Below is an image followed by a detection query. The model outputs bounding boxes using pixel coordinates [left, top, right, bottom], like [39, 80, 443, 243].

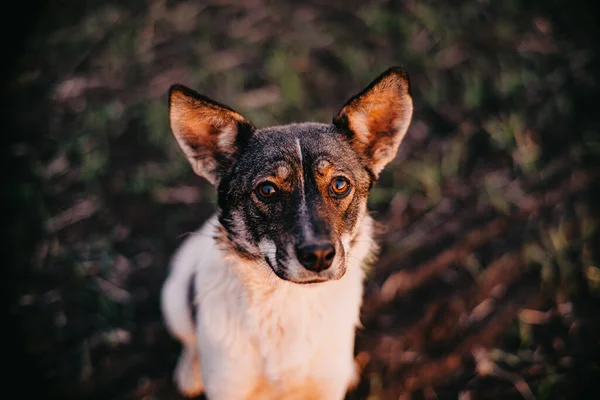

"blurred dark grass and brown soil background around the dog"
[2, 0, 600, 400]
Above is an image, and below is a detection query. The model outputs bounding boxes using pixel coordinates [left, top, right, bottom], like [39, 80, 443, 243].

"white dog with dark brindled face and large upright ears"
[161, 67, 413, 400]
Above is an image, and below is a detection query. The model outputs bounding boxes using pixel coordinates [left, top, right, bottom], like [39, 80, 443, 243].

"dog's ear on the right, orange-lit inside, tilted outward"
[333, 67, 413, 177]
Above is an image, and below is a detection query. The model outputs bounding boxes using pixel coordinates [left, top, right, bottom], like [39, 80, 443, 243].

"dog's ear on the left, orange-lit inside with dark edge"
[169, 85, 255, 184]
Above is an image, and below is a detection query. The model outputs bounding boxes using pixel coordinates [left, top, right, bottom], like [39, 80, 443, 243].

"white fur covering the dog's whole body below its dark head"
[162, 216, 373, 400]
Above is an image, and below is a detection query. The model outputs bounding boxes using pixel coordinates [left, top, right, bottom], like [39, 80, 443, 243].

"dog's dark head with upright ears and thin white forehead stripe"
[169, 67, 413, 283]
